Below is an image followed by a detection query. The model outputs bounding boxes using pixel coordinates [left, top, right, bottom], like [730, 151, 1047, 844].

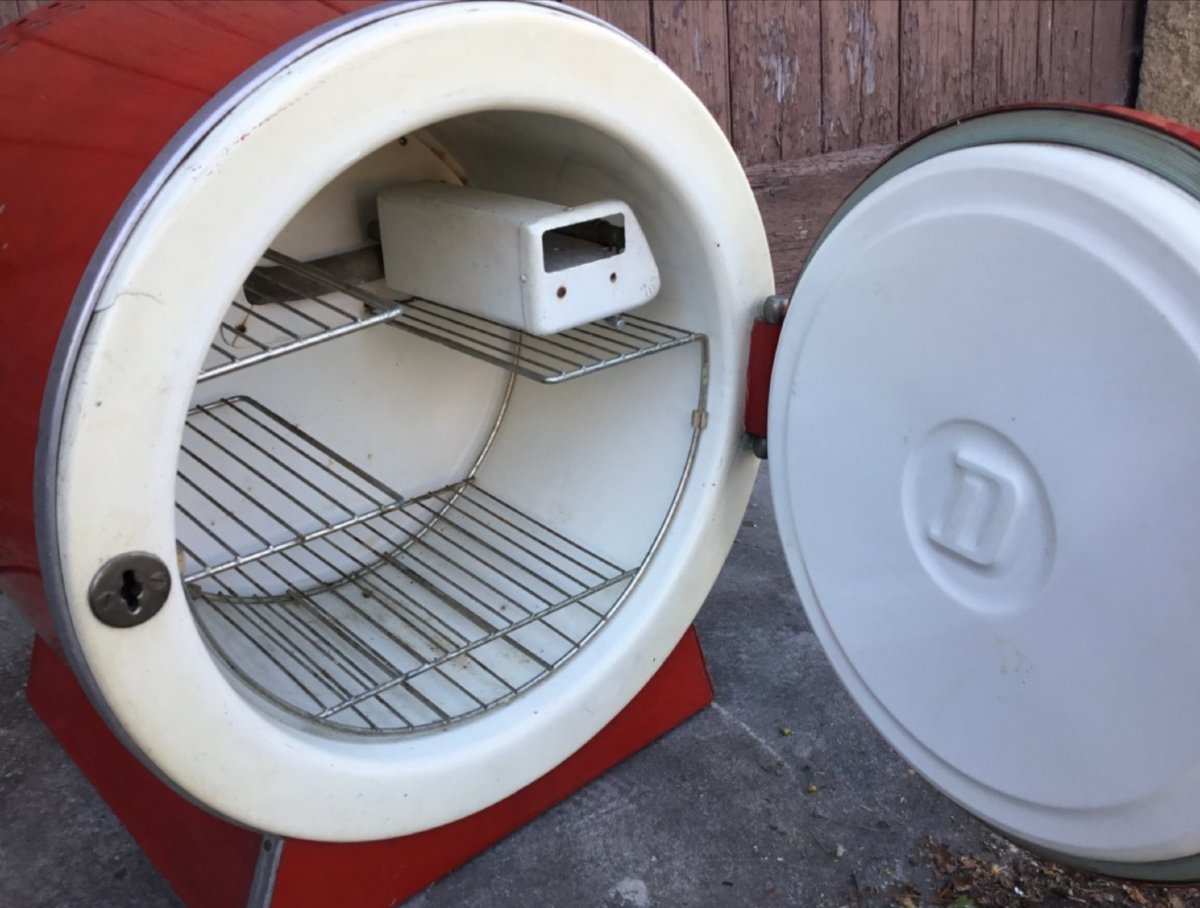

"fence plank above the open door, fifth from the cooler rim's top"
[899, 0, 972, 139]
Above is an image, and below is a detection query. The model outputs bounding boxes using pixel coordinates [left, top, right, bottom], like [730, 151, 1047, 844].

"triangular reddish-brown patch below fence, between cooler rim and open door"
[746, 144, 895, 293]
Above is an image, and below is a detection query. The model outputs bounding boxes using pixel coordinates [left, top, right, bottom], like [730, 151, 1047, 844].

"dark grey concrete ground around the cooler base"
[0, 471, 1027, 908]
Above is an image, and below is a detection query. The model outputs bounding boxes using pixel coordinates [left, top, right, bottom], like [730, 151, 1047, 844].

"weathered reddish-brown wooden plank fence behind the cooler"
[0, 0, 1144, 287]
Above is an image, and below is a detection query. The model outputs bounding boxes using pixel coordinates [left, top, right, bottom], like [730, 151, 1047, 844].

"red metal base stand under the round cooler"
[28, 631, 713, 908]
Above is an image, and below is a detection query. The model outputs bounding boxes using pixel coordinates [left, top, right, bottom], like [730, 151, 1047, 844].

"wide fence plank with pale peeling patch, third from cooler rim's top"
[728, 0, 821, 164]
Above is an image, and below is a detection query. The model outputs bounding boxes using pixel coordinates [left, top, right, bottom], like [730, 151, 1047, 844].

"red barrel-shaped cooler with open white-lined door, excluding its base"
[11, 2, 1200, 878]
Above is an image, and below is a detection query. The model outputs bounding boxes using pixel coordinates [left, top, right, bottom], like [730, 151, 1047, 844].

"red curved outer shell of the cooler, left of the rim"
[0, 0, 374, 642]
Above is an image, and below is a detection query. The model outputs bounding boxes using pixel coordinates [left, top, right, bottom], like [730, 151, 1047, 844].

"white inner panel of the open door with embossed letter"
[770, 144, 1200, 862]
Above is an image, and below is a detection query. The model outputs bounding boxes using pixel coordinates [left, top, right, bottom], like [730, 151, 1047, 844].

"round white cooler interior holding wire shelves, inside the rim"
[176, 112, 715, 735]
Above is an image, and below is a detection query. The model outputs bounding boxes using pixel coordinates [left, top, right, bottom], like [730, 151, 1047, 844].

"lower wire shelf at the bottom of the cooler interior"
[176, 397, 641, 734]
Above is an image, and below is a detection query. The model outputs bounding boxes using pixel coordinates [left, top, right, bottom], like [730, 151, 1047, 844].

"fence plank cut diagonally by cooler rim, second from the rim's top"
[650, 0, 730, 136]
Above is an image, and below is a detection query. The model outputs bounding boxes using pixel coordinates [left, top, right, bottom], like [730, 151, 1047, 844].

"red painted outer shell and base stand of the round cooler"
[0, 0, 712, 908]
